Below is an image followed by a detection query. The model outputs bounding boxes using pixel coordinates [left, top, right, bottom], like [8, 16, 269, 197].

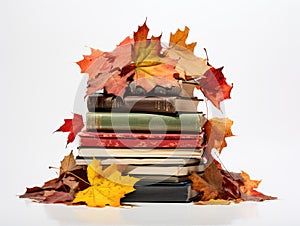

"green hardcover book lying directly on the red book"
[86, 112, 206, 133]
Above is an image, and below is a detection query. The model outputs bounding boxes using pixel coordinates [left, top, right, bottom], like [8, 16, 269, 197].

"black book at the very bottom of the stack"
[121, 181, 199, 202]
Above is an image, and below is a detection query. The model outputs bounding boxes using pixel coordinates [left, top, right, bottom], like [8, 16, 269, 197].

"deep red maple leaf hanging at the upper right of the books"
[197, 67, 233, 109]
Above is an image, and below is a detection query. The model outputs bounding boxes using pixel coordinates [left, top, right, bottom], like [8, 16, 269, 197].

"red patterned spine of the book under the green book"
[80, 136, 203, 148]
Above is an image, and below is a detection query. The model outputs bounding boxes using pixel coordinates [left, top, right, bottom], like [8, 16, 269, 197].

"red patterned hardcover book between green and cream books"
[79, 132, 203, 148]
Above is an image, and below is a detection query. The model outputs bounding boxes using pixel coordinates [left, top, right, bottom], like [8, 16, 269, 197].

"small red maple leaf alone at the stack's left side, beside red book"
[54, 113, 84, 146]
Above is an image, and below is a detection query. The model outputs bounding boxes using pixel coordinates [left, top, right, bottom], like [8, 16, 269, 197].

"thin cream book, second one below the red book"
[75, 156, 201, 166]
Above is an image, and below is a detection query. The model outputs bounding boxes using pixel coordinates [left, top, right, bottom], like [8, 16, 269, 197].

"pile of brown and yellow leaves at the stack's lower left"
[20, 152, 139, 207]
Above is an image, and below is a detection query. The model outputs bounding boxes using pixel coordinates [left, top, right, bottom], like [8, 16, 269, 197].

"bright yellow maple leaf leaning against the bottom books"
[73, 159, 139, 207]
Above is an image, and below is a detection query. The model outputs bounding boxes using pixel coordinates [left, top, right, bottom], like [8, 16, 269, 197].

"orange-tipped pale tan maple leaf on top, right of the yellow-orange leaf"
[166, 27, 211, 80]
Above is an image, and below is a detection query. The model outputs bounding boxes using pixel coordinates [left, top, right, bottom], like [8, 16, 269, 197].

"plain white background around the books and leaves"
[0, 0, 300, 225]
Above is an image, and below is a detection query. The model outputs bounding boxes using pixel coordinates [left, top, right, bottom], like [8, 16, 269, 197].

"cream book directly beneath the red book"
[78, 146, 203, 159]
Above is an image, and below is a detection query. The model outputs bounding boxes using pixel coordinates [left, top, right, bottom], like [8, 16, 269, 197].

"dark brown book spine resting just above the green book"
[87, 95, 176, 114]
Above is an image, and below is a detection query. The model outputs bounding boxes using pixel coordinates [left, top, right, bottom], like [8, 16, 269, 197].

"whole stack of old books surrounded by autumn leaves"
[76, 85, 206, 202]
